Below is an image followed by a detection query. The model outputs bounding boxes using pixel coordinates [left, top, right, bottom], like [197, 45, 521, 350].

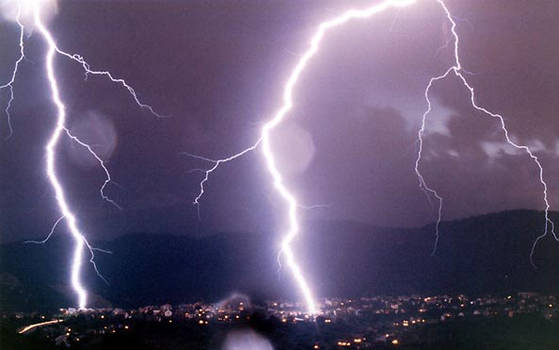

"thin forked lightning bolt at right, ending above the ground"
[415, 0, 559, 267]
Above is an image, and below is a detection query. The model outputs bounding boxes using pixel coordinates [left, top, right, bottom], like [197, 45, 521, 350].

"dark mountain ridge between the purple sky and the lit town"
[0, 210, 559, 310]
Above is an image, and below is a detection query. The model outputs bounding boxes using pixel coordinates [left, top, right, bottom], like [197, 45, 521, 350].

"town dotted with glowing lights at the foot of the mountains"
[6, 293, 559, 349]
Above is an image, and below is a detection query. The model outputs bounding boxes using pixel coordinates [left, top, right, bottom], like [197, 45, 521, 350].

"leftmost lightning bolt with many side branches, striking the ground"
[0, 0, 164, 309]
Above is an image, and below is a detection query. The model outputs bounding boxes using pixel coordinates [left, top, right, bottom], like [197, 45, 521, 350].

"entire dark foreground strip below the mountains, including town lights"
[0, 293, 559, 350]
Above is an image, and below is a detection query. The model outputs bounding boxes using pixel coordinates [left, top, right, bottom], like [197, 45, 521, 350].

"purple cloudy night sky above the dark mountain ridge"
[0, 0, 559, 241]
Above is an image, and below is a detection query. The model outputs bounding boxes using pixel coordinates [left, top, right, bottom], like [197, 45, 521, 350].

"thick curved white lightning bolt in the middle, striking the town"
[194, 0, 415, 314]
